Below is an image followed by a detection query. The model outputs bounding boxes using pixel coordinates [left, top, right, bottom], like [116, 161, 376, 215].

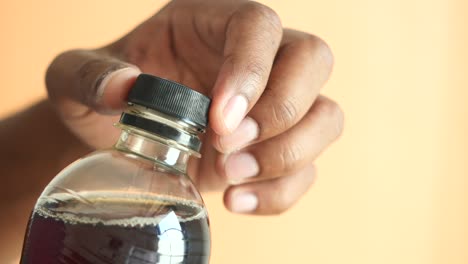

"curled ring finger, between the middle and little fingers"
[216, 96, 343, 183]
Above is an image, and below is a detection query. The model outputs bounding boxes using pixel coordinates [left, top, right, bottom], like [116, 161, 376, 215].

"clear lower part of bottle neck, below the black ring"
[114, 129, 190, 174]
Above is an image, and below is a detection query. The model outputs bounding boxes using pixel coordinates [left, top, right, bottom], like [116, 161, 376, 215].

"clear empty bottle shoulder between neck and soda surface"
[41, 149, 203, 204]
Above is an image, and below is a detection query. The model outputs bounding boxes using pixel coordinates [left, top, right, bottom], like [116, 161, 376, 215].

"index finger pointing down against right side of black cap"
[210, 2, 283, 135]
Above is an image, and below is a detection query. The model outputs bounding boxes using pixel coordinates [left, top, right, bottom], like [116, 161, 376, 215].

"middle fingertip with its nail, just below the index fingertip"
[219, 117, 259, 153]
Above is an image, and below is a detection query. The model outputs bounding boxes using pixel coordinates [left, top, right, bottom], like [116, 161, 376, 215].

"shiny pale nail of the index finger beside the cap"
[223, 95, 248, 132]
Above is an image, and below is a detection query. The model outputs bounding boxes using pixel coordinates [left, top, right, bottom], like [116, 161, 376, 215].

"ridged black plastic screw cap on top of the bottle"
[128, 74, 211, 128]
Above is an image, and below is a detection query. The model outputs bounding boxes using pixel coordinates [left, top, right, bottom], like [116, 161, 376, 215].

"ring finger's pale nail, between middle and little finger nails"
[224, 152, 260, 181]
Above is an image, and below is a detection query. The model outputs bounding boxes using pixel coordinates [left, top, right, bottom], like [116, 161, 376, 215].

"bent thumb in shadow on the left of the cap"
[46, 50, 141, 113]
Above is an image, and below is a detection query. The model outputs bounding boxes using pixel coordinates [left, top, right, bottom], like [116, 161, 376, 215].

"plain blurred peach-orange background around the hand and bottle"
[0, 0, 468, 264]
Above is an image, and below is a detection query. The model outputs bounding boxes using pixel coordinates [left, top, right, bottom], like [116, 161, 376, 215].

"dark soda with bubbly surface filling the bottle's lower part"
[21, 192, 210, 264]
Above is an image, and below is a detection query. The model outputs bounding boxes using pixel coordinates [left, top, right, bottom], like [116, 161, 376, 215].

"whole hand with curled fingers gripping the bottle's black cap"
[46, 0, 343, 214]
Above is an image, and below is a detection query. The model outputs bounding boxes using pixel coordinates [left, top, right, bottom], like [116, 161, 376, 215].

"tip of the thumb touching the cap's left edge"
[97, 67, 141, 112]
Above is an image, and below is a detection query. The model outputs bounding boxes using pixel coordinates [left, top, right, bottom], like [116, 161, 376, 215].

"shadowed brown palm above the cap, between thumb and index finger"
[116, 5, 223, 94]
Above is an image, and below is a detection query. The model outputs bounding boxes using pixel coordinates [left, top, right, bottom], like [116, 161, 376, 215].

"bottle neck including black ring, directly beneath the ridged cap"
[114, 104, 204, 173]
